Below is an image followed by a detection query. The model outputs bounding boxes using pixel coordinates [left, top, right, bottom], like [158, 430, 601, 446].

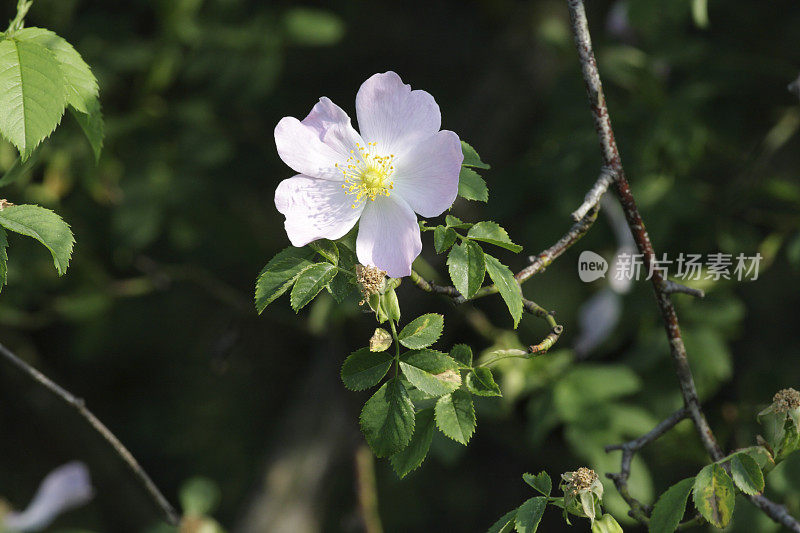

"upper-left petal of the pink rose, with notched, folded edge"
[275, 98, 364, 181]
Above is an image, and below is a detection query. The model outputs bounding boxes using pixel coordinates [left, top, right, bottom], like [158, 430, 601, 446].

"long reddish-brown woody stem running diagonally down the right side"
[567, 0, 800, 533]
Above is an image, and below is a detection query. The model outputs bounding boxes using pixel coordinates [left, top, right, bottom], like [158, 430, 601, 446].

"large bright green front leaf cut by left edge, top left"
[0, 39, 67, 160]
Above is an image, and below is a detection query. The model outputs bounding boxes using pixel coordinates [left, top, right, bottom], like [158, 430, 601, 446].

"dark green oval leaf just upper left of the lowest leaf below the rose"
[359, 378, 414, 457]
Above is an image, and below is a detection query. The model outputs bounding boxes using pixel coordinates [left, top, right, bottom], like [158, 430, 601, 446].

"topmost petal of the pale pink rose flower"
[356, 71, 442, 156]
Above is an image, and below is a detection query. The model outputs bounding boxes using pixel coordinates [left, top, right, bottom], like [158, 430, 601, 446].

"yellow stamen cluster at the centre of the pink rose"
[335, 142, 394, 209]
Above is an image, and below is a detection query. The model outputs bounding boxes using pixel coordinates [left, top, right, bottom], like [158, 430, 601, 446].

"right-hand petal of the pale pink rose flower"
[392, 130, 464, 217]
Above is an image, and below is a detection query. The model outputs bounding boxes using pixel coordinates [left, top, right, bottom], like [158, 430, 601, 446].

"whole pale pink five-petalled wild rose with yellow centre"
[275, 72, 464, 278]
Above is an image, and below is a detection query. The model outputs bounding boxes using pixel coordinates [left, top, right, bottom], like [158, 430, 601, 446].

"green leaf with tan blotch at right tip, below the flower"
[400, 350, 461, 397]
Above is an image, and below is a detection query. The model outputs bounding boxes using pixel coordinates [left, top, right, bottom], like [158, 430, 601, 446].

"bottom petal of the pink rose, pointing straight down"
[356, 195, 422, 278]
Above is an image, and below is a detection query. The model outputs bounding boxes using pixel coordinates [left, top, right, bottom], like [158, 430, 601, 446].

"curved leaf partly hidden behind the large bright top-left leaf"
[14, 27, 99, 114]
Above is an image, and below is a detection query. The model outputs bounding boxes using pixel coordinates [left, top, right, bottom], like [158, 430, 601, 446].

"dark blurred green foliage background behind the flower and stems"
[0, 0, 800, 532]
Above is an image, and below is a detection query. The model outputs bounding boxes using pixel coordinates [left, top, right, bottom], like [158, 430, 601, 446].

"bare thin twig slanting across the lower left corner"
[0, 344, 178, 525]
